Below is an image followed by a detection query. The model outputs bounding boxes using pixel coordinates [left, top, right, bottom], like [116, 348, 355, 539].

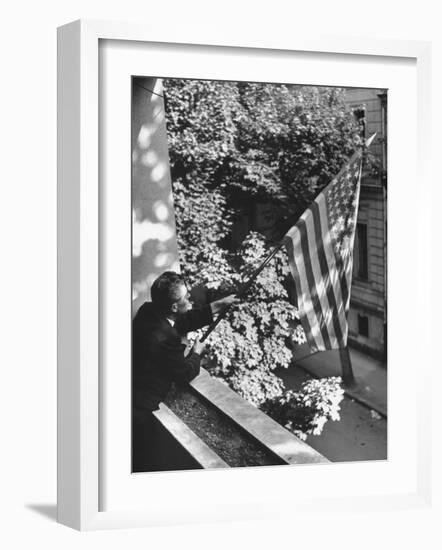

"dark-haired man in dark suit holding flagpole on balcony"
[132, 271, 236, 472]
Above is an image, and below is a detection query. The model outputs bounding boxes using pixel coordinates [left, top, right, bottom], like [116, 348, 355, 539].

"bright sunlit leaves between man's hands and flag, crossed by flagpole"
[201, 233, 304, 406]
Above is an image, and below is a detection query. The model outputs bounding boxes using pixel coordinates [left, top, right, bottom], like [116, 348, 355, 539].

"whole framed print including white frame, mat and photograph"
[58, 21, 430, 529]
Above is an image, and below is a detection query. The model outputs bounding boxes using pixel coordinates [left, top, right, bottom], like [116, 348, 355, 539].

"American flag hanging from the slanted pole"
[284, 142, 374, 351]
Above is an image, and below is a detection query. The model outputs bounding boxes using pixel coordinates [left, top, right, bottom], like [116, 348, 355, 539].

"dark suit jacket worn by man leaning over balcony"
[132, 302, 212, 411]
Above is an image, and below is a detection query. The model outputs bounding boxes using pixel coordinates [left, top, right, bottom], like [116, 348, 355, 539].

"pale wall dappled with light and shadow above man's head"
[132, 78, 179, 314]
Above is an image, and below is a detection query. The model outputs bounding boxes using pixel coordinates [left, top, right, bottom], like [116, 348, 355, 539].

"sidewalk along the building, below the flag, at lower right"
[289, 344, 387, 418]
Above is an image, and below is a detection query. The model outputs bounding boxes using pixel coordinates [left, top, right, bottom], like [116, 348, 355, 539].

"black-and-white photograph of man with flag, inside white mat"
[128, 76, 388, 473]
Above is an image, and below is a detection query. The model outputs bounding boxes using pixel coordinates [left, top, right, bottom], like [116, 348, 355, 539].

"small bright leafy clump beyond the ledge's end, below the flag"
[262, 377, 344, 439]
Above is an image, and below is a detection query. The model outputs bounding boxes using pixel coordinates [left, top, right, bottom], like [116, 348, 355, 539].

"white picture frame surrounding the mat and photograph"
[58, 21, 431, 530]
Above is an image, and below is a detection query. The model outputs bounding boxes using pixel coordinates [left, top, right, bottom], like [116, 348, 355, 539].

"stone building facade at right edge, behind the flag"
[346, 88, 387, 359]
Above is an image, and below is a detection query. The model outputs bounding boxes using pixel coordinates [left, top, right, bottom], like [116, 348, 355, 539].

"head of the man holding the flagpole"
[150, 271, 192, 318]
